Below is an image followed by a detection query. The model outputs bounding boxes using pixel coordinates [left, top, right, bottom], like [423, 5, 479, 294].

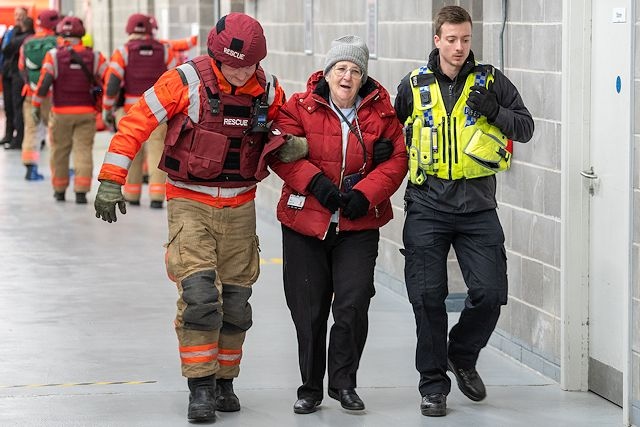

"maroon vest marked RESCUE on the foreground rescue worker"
[158, 55, 273, 187]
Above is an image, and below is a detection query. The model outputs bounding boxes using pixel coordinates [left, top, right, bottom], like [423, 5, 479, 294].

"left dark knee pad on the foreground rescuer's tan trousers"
[182, 271, 222, 331]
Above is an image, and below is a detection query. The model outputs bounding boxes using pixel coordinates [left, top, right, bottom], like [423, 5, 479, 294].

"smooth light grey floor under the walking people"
[0, 129, 622, 427]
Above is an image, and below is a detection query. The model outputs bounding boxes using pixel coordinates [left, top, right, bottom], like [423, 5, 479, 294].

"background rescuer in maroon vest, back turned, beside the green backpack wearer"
[31, 16, 107, 204]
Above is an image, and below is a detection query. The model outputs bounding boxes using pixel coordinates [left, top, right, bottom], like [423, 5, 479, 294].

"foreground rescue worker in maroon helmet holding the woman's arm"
[95, 13, 304, 421]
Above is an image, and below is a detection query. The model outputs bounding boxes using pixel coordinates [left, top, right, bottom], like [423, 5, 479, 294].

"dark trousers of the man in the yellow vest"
[403, 202, 507, 396]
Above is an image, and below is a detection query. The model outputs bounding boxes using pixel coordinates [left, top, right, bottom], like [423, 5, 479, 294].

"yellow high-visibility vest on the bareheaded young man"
[405, 65, 511, 185]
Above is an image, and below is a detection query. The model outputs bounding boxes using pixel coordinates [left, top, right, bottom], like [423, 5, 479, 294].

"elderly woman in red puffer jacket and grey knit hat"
[271, 36, 407, 414]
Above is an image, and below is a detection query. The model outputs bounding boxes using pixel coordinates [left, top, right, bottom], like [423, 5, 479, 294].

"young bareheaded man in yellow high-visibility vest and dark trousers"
[395, 6, 534, 416]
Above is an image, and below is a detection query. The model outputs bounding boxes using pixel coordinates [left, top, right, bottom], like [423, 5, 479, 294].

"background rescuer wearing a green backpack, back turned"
[18, 9, 61, 181]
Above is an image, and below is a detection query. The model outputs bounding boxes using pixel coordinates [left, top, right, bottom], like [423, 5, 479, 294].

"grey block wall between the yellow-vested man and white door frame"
[482, 0, 562, 381]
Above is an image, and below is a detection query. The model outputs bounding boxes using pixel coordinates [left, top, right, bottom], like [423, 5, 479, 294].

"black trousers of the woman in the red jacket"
[282, 225, 380, 400]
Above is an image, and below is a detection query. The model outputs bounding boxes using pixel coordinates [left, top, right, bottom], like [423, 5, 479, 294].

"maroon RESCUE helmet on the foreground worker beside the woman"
[207, 12, 267, 68]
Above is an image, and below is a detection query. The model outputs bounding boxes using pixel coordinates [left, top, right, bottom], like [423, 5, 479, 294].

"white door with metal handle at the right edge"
[582, 0, 634, 406]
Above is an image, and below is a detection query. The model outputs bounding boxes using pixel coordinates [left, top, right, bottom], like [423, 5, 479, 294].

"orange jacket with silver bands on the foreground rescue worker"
[98, 60, 286, 206]
